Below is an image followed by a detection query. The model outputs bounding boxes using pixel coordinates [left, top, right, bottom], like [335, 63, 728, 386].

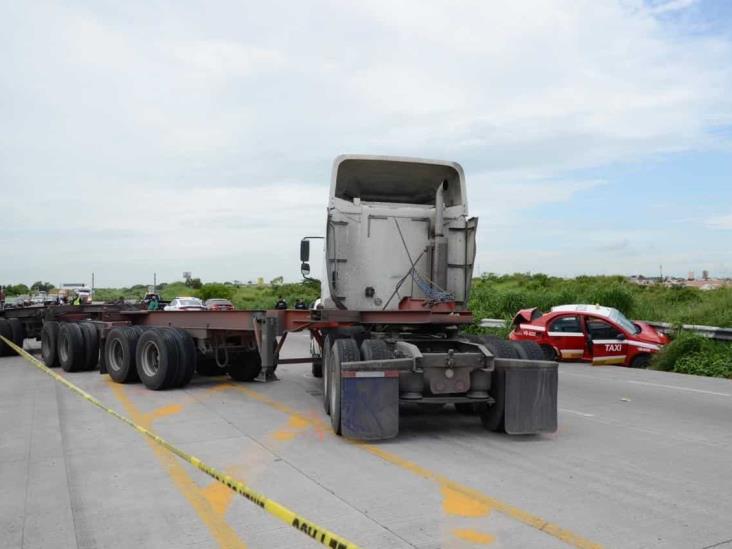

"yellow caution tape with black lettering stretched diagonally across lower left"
[0, 336, 358, 549]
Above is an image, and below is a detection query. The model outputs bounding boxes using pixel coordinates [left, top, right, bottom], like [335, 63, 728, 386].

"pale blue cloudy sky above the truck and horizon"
[0, 0, 732, 287]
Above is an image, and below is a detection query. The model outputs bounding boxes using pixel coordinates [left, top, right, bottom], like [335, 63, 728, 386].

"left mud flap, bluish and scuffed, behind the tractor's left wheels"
[341, 372, 399, 440]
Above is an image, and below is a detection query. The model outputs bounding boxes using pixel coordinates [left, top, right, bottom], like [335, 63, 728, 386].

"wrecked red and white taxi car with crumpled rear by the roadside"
[509, 305, 669, 368]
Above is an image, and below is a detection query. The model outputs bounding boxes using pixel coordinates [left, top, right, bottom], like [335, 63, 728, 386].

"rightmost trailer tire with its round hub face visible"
[135, 328, 181, 391]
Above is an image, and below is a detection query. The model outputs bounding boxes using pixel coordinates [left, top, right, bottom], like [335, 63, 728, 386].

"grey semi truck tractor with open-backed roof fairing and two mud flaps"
[300, 155, 557, 439]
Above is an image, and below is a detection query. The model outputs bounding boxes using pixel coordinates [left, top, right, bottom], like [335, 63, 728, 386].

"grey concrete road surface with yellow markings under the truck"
[0, 337, 732, 549]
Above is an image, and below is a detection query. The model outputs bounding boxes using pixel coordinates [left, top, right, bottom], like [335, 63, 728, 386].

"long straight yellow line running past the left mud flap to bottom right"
[230, 384, 602, 549]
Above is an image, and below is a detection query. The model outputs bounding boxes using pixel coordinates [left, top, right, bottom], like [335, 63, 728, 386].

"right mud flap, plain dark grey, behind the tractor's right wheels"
[494, 359, 558, 435]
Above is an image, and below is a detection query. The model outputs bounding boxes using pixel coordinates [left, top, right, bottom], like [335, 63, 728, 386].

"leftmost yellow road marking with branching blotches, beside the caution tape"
[108, 381, 246, 549]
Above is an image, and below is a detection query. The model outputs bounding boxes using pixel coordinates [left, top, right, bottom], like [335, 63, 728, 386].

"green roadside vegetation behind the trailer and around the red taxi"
[6, 273, 732, 378]
